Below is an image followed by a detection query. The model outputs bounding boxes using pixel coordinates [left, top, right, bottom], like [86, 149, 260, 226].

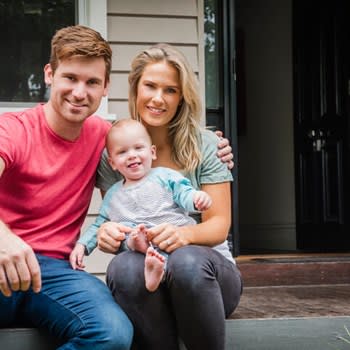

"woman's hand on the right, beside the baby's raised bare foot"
[147, 223, 190, 253]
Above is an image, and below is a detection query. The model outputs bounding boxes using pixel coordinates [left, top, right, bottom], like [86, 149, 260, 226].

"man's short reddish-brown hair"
[50, 25, 112, 82]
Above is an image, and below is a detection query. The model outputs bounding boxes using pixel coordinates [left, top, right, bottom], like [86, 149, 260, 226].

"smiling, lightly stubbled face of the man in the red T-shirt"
[44, 57, 108, 124]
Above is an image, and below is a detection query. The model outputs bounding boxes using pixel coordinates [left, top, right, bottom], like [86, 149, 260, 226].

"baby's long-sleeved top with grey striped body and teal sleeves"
[79, 167, 197, 254]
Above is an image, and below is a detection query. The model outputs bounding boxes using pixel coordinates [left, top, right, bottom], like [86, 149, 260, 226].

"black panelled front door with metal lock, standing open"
[293, 0, 350, 251]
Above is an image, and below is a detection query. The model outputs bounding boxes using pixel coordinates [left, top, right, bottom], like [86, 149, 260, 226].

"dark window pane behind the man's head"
[0, 0, 77, 105]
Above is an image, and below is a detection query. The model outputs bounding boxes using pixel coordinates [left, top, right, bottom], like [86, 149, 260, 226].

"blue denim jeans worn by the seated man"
[0, 255, 133, 350]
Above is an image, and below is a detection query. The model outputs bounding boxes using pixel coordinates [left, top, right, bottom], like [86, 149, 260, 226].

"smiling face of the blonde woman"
[136, 61, 182, 127]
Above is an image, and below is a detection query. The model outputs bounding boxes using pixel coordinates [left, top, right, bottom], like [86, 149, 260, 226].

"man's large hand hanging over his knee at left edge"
[0, 221, 41, 297]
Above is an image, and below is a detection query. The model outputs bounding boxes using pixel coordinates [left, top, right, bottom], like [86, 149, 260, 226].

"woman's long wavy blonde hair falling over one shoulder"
[129, 44, 202, 172]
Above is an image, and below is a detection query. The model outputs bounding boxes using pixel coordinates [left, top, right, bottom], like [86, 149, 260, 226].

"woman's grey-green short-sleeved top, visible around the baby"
[96, 129, 234, 262]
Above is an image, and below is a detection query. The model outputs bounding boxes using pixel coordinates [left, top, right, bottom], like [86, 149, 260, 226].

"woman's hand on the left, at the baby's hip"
[97, 221, 132, 254]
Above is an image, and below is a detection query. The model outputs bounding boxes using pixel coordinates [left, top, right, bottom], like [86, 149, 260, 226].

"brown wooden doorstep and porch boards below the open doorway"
[230, 254, 350, 320]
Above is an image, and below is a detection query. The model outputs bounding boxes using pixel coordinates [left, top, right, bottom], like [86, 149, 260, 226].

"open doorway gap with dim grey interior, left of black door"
[235, 0, 297, 253]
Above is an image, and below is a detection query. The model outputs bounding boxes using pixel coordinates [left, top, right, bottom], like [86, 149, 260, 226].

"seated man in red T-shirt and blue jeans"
[0, 26, 133, 350]
